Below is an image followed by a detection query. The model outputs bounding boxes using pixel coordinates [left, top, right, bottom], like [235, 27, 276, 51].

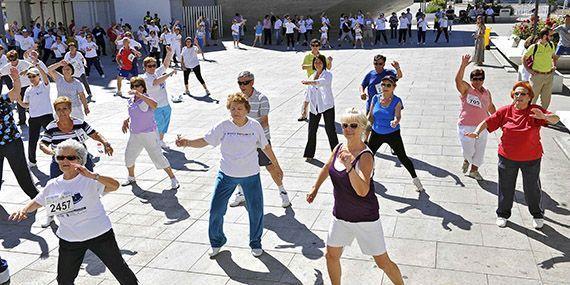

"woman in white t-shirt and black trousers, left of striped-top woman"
[14, 65, 53, 167]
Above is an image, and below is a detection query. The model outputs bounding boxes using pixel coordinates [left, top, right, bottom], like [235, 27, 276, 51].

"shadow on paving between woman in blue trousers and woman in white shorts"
[263, 207, 325, 259]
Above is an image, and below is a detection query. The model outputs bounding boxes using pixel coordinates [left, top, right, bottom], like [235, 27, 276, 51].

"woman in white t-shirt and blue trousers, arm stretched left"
[176, 93, 283, 257]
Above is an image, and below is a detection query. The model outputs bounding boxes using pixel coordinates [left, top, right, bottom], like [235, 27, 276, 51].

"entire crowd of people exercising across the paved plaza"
[0, 9, 560, 284]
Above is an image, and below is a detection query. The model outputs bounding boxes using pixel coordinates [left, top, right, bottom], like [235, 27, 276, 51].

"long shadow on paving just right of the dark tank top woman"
[374, 181, 473, 231]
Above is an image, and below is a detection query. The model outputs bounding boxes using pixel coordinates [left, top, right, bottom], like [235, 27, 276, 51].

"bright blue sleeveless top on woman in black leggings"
[370, 95, 404, 135]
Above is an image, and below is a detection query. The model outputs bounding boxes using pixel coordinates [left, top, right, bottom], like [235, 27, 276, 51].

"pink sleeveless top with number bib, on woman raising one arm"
[457, 88, 491, 126]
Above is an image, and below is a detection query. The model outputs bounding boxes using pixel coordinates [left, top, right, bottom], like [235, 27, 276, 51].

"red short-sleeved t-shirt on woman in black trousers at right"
[485, 104, 550, 161]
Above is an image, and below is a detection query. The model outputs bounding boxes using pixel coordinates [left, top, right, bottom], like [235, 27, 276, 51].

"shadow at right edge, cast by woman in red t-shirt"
[507, 222, 570, 269]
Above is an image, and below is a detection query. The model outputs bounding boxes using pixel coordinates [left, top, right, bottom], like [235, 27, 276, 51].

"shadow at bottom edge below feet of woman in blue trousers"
[215, 250, 302, 284]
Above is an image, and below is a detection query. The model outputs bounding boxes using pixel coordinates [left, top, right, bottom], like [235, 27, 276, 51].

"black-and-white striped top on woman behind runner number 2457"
[41, 118, 95, 147]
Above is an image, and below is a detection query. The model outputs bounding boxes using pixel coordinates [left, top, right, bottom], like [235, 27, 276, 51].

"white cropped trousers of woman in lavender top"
[125, 132, 170, 169]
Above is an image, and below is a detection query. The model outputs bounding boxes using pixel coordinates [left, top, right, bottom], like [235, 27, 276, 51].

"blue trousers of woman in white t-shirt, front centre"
[208, 171, 263, 248]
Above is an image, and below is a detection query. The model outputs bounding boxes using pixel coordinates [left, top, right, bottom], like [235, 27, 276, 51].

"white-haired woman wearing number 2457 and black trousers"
[9, 139, 138, 285]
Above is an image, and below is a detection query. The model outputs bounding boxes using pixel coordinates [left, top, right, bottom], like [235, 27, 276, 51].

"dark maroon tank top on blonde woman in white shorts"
[329, 144, 380, 223]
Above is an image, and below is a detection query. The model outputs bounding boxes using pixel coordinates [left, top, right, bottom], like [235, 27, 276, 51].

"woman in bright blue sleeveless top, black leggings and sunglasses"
[368, 75, 424, 192]
